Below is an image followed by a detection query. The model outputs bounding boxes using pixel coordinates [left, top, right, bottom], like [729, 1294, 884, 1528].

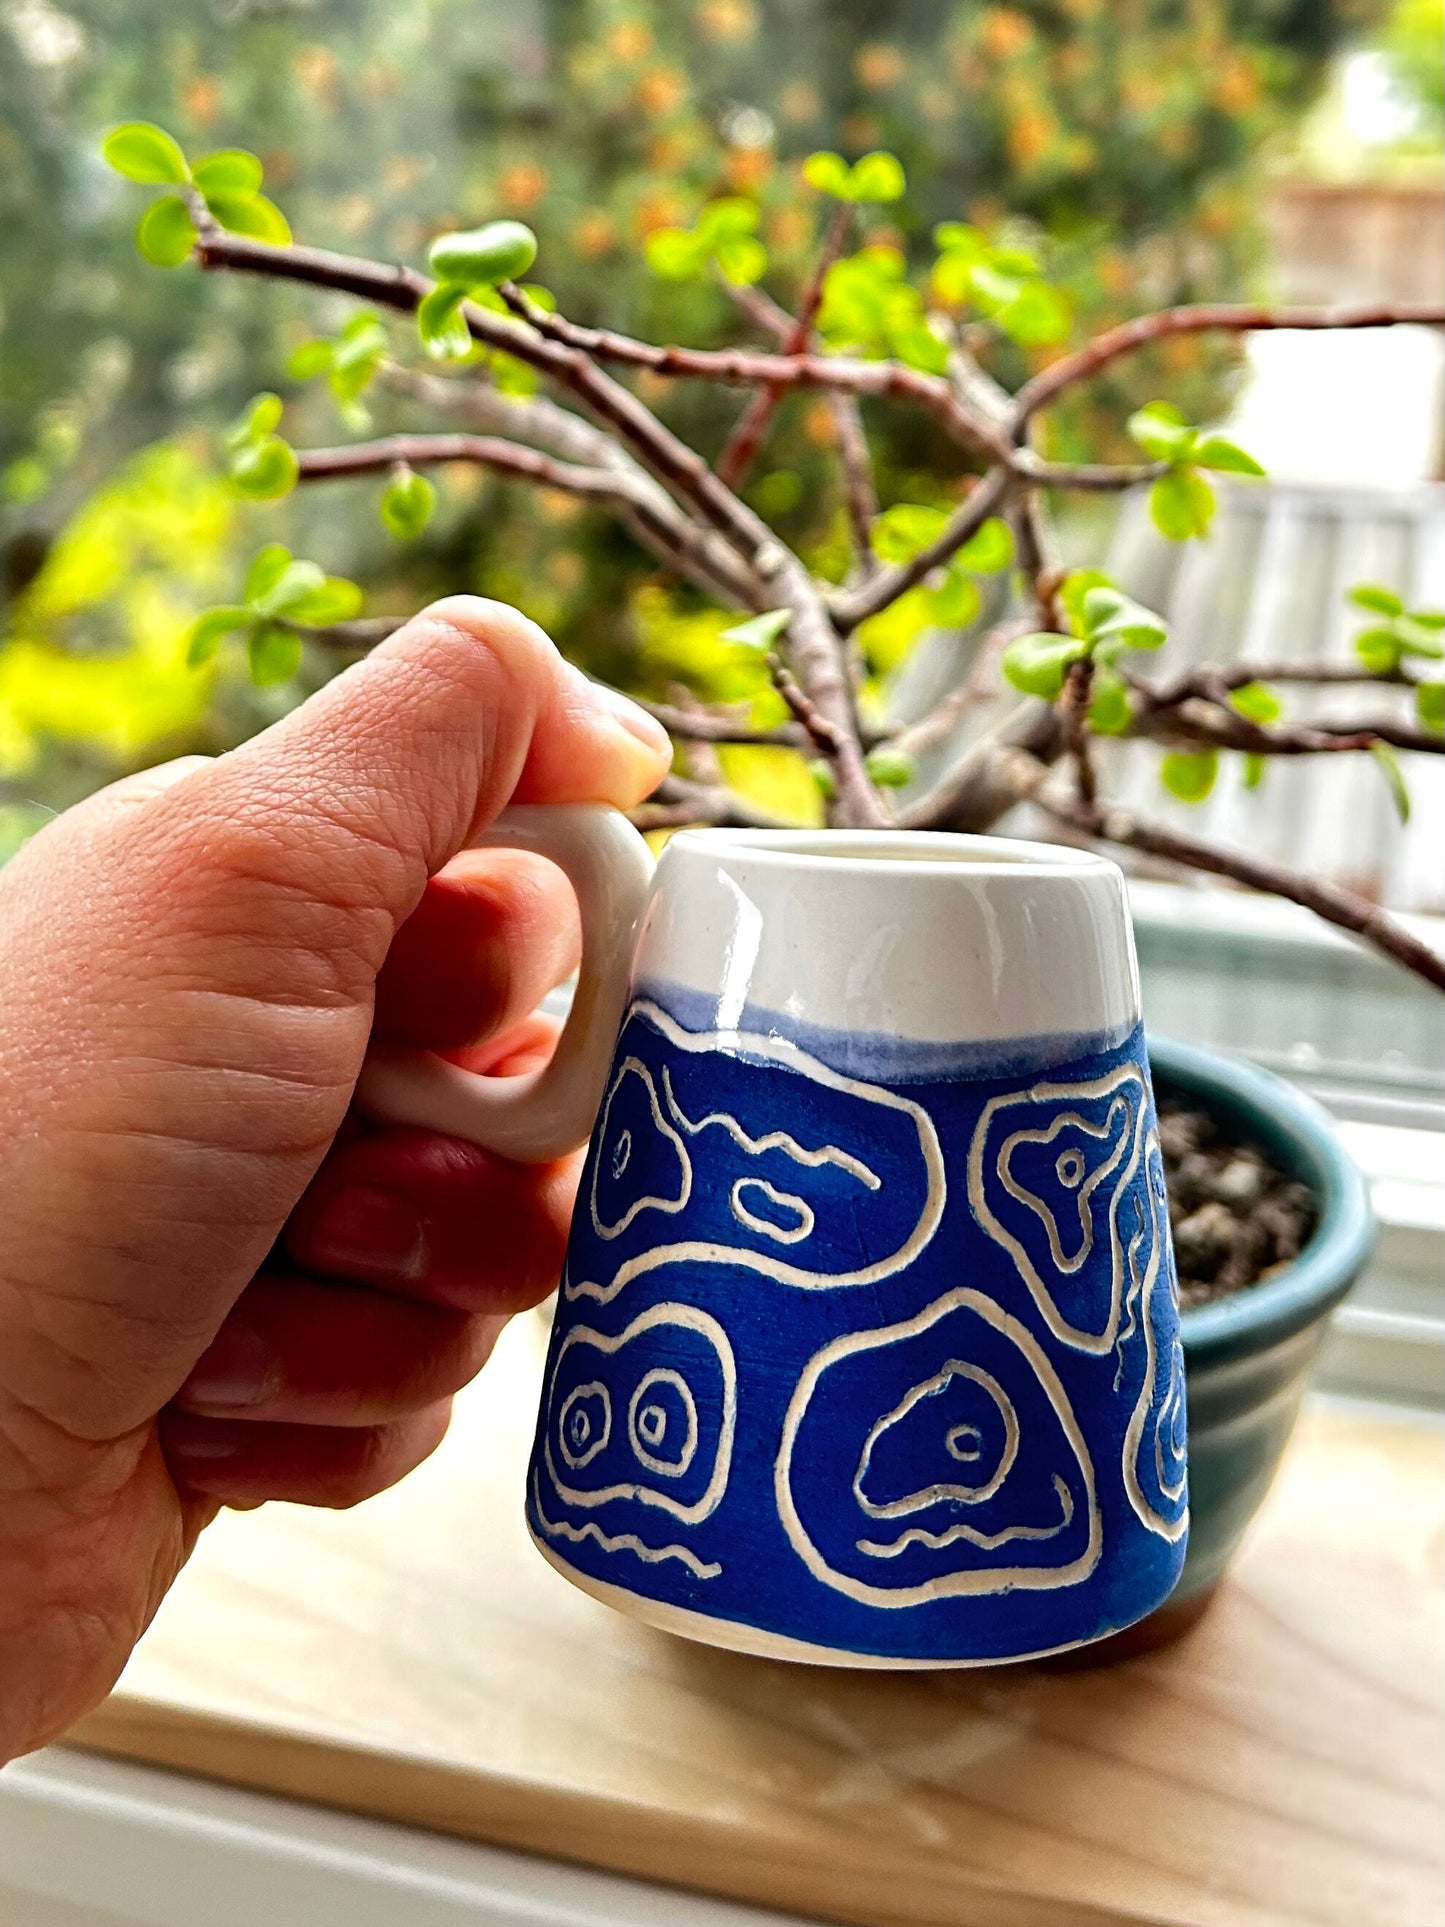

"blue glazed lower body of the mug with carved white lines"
[528, 985, 1187, 1663]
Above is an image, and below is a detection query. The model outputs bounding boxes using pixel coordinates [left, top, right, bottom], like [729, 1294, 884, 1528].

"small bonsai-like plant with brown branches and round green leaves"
[106, 123, 1445, 989]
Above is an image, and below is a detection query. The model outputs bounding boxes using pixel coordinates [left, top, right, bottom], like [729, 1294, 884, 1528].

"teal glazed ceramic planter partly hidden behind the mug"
[1148, 1037, 1376, 1623]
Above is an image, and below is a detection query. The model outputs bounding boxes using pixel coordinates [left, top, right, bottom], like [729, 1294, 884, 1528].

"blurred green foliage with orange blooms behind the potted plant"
[0, 0, 1381, 820]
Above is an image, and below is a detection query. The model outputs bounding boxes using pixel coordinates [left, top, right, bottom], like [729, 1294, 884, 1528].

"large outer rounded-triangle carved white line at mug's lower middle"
[773, 1285, 1104, 1609]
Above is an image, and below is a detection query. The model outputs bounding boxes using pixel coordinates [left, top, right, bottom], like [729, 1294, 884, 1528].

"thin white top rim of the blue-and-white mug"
[667, 829, 1123, 881]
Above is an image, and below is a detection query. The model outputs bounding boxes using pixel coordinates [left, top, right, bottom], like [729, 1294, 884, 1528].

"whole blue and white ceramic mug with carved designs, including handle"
[362, 807, 1189, 1667]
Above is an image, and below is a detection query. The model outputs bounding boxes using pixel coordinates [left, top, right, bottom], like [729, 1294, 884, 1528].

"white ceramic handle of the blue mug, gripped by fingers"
[356, 804, 653, 1164]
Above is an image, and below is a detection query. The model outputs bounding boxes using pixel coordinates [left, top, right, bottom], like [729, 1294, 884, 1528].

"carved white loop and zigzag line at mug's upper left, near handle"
[565, 998, 946, 1305]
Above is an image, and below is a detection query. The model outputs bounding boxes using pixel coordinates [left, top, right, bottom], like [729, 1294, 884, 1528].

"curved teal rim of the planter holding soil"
[1148, 1037, 1376, 1364]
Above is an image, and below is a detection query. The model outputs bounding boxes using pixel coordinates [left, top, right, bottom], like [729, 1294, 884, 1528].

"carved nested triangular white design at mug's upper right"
[969, 1064, 1146, 1357]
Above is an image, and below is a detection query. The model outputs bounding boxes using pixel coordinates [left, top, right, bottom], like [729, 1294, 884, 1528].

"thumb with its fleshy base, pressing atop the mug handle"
[0, 597, 669, 1438]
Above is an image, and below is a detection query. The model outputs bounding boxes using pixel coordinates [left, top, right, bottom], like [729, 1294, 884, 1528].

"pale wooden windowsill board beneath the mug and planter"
[71, 1318, 1445, 1927]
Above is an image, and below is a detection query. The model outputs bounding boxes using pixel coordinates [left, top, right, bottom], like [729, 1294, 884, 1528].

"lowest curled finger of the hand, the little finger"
[160, 1401, 451, 1509]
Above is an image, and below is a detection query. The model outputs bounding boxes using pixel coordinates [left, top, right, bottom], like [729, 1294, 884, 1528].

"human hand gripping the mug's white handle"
[0, 597, 669, 1761]
